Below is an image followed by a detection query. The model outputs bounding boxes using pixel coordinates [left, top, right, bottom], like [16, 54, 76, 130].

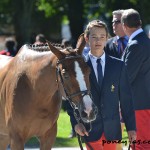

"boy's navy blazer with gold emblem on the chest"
[68, 55, 136, 141]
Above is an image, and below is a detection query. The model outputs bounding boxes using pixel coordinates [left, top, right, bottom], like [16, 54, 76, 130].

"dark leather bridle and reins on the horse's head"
[56, 55, 93, 150]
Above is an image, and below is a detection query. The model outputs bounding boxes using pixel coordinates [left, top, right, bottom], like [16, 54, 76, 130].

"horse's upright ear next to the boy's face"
[76, 33, 86, 55]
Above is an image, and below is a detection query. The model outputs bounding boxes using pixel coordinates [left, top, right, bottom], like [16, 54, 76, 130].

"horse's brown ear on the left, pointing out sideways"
[46, 41, 65, 59]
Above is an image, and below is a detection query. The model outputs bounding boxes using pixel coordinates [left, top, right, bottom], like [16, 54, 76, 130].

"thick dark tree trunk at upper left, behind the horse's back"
[12, 0, 35, 47]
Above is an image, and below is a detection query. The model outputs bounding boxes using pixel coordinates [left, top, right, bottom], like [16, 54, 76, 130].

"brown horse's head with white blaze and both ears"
[48, 35, 97, 122]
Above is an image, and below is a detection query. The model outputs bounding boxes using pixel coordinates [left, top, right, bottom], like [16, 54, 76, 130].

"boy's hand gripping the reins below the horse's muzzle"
[74, 123, 89, 136]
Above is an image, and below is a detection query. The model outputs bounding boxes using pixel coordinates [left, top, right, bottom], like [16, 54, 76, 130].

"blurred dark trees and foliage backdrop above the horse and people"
[0, 0, 150, 49]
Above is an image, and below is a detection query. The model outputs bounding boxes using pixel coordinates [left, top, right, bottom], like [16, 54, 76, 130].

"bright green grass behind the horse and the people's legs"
[26, 110, 128, 147]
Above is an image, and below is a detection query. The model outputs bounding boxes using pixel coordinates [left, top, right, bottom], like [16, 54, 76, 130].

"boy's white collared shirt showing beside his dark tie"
[89, 51, 106, 81]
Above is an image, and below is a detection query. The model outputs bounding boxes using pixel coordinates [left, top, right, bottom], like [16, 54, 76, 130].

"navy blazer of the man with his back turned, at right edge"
[123, 32, 150, 110]
